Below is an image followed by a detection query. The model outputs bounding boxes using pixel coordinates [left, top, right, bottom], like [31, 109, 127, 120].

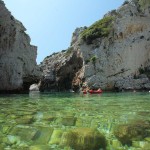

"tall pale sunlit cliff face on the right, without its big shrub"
[73, 0, 150, 90]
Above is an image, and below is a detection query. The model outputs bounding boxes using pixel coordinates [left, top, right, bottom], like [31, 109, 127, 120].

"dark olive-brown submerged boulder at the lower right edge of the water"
[114, 121, 150, 146]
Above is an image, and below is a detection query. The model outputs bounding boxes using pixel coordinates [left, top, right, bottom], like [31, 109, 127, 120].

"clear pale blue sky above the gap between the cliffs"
[3, 0, 124, 64]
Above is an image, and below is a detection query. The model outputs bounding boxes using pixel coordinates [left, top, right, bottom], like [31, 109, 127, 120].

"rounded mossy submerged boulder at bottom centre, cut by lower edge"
[60, 128, 106, 150]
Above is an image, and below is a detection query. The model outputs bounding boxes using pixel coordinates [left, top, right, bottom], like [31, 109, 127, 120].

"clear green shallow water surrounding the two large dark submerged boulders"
[0, 92, 150, 150]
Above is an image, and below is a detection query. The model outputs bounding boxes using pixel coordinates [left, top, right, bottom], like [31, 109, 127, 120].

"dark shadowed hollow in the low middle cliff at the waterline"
[40, 52, 83, 92]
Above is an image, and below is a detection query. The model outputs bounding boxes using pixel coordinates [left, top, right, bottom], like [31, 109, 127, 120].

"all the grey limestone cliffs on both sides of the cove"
[0, 0, 150, 91]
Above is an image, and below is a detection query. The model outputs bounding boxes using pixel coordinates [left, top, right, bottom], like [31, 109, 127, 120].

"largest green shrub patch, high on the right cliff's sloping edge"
[81, 16, 114, 44]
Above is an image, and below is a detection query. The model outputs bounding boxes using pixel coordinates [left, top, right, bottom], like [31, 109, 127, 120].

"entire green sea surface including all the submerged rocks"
[0, 92, 150, 150]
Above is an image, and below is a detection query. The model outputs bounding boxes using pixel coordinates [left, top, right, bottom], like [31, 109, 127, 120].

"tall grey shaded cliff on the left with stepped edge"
[0, 0, 40, 92]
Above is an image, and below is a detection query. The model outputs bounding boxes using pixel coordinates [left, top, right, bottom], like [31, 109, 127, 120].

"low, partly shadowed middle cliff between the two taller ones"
[40, 47, 83, 91]
